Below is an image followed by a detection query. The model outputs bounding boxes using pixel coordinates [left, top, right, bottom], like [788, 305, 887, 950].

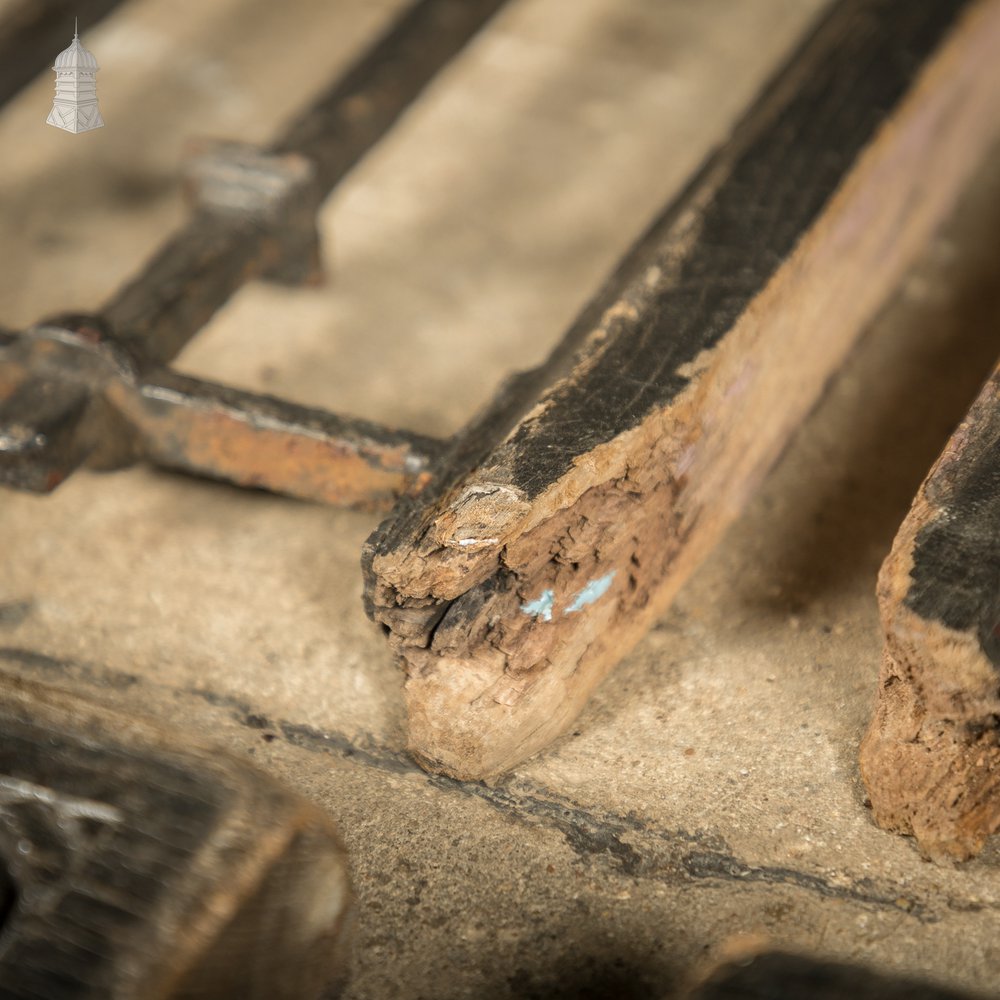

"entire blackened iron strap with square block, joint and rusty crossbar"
[0, 0, 503, 507]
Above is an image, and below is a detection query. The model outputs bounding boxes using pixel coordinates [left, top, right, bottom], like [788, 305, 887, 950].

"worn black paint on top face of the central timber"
[497, 0, 969, 500]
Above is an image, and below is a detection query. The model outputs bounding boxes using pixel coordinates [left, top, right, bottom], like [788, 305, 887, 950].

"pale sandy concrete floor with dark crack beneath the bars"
[0, 0, 1000, 1000]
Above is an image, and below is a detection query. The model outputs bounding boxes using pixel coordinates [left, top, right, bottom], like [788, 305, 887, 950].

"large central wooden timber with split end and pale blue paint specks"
[364, 0, 1000, 778]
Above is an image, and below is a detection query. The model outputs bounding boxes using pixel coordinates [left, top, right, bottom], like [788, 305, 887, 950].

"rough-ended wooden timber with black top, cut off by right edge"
[861, 368, 1000, 860]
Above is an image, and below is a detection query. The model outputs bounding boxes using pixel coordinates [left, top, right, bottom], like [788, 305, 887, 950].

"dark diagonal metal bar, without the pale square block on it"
[103, 0, 503, 364]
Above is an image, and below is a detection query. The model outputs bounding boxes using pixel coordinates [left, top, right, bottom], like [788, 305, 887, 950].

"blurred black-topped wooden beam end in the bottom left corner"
[0, 676, 351, 1000]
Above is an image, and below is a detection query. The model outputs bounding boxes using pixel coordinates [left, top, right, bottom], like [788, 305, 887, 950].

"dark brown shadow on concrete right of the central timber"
[734, 140, 1000, 614]
